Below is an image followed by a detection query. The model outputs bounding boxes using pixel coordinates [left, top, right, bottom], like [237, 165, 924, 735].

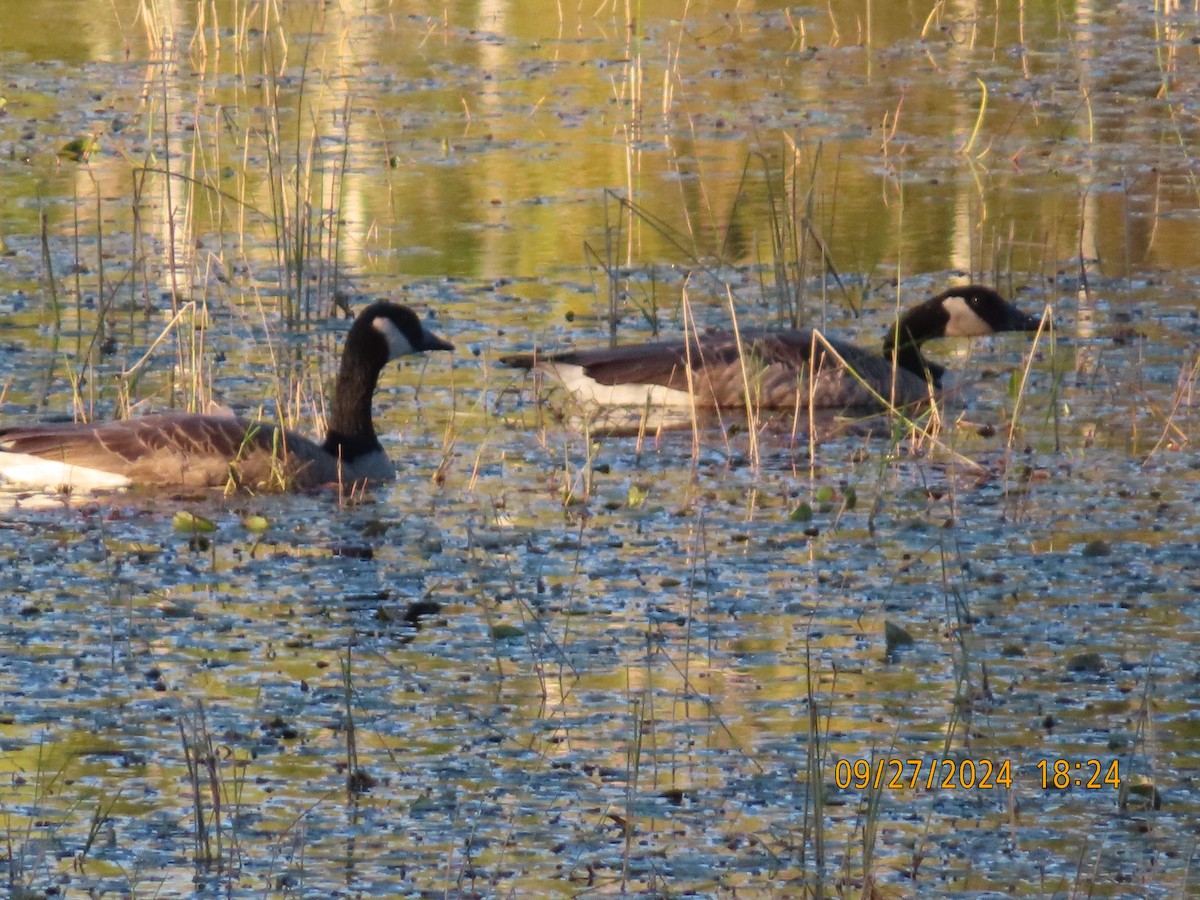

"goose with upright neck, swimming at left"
[0, 302, 454, 490]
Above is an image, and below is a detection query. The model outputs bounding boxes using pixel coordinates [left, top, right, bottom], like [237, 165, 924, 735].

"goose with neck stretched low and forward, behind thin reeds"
[500, 284, 1039, 409]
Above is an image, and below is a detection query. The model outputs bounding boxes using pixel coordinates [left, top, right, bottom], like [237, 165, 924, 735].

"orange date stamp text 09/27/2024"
[833, 756, 1013, 791]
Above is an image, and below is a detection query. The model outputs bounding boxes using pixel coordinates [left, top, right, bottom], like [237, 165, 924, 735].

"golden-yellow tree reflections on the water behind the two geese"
[0, 2, 1198, 314]
